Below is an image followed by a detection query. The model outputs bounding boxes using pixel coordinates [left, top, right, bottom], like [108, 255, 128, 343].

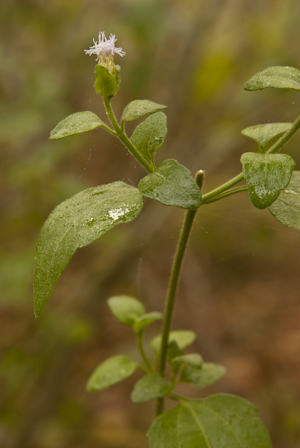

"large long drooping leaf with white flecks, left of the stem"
[34, 182, 143, 316]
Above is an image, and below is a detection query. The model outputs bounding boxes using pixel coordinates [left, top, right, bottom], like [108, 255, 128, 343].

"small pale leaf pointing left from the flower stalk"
[50, 111, 104, 140]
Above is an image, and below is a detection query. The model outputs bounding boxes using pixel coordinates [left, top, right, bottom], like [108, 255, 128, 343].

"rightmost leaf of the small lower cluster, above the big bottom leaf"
[180, 362, 226, 387]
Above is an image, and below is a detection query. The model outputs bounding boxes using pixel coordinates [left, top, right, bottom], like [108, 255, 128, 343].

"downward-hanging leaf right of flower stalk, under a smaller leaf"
[131, 112, 167, 162]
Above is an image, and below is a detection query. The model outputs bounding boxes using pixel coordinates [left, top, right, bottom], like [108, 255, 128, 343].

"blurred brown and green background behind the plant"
[0, 0, 300, 448]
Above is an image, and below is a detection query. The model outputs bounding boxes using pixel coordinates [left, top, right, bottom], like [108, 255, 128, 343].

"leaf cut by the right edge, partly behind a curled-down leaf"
[269, 171, 300, 230]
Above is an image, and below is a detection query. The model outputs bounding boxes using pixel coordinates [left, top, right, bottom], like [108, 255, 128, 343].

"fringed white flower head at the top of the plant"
[84, 31, 126, 74]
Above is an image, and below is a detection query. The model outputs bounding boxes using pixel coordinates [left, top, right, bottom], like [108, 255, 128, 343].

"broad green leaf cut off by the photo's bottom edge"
[148, 394, 271, 448]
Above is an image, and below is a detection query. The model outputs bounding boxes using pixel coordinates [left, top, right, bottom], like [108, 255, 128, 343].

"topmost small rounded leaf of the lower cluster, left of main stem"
[107, 296, 145, 327]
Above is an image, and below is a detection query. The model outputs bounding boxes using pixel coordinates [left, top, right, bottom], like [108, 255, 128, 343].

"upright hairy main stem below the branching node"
[156, 210, 197, 415]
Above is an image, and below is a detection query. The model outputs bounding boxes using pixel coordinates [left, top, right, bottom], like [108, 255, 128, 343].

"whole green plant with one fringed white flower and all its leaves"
[34, 32, 300, 448]
